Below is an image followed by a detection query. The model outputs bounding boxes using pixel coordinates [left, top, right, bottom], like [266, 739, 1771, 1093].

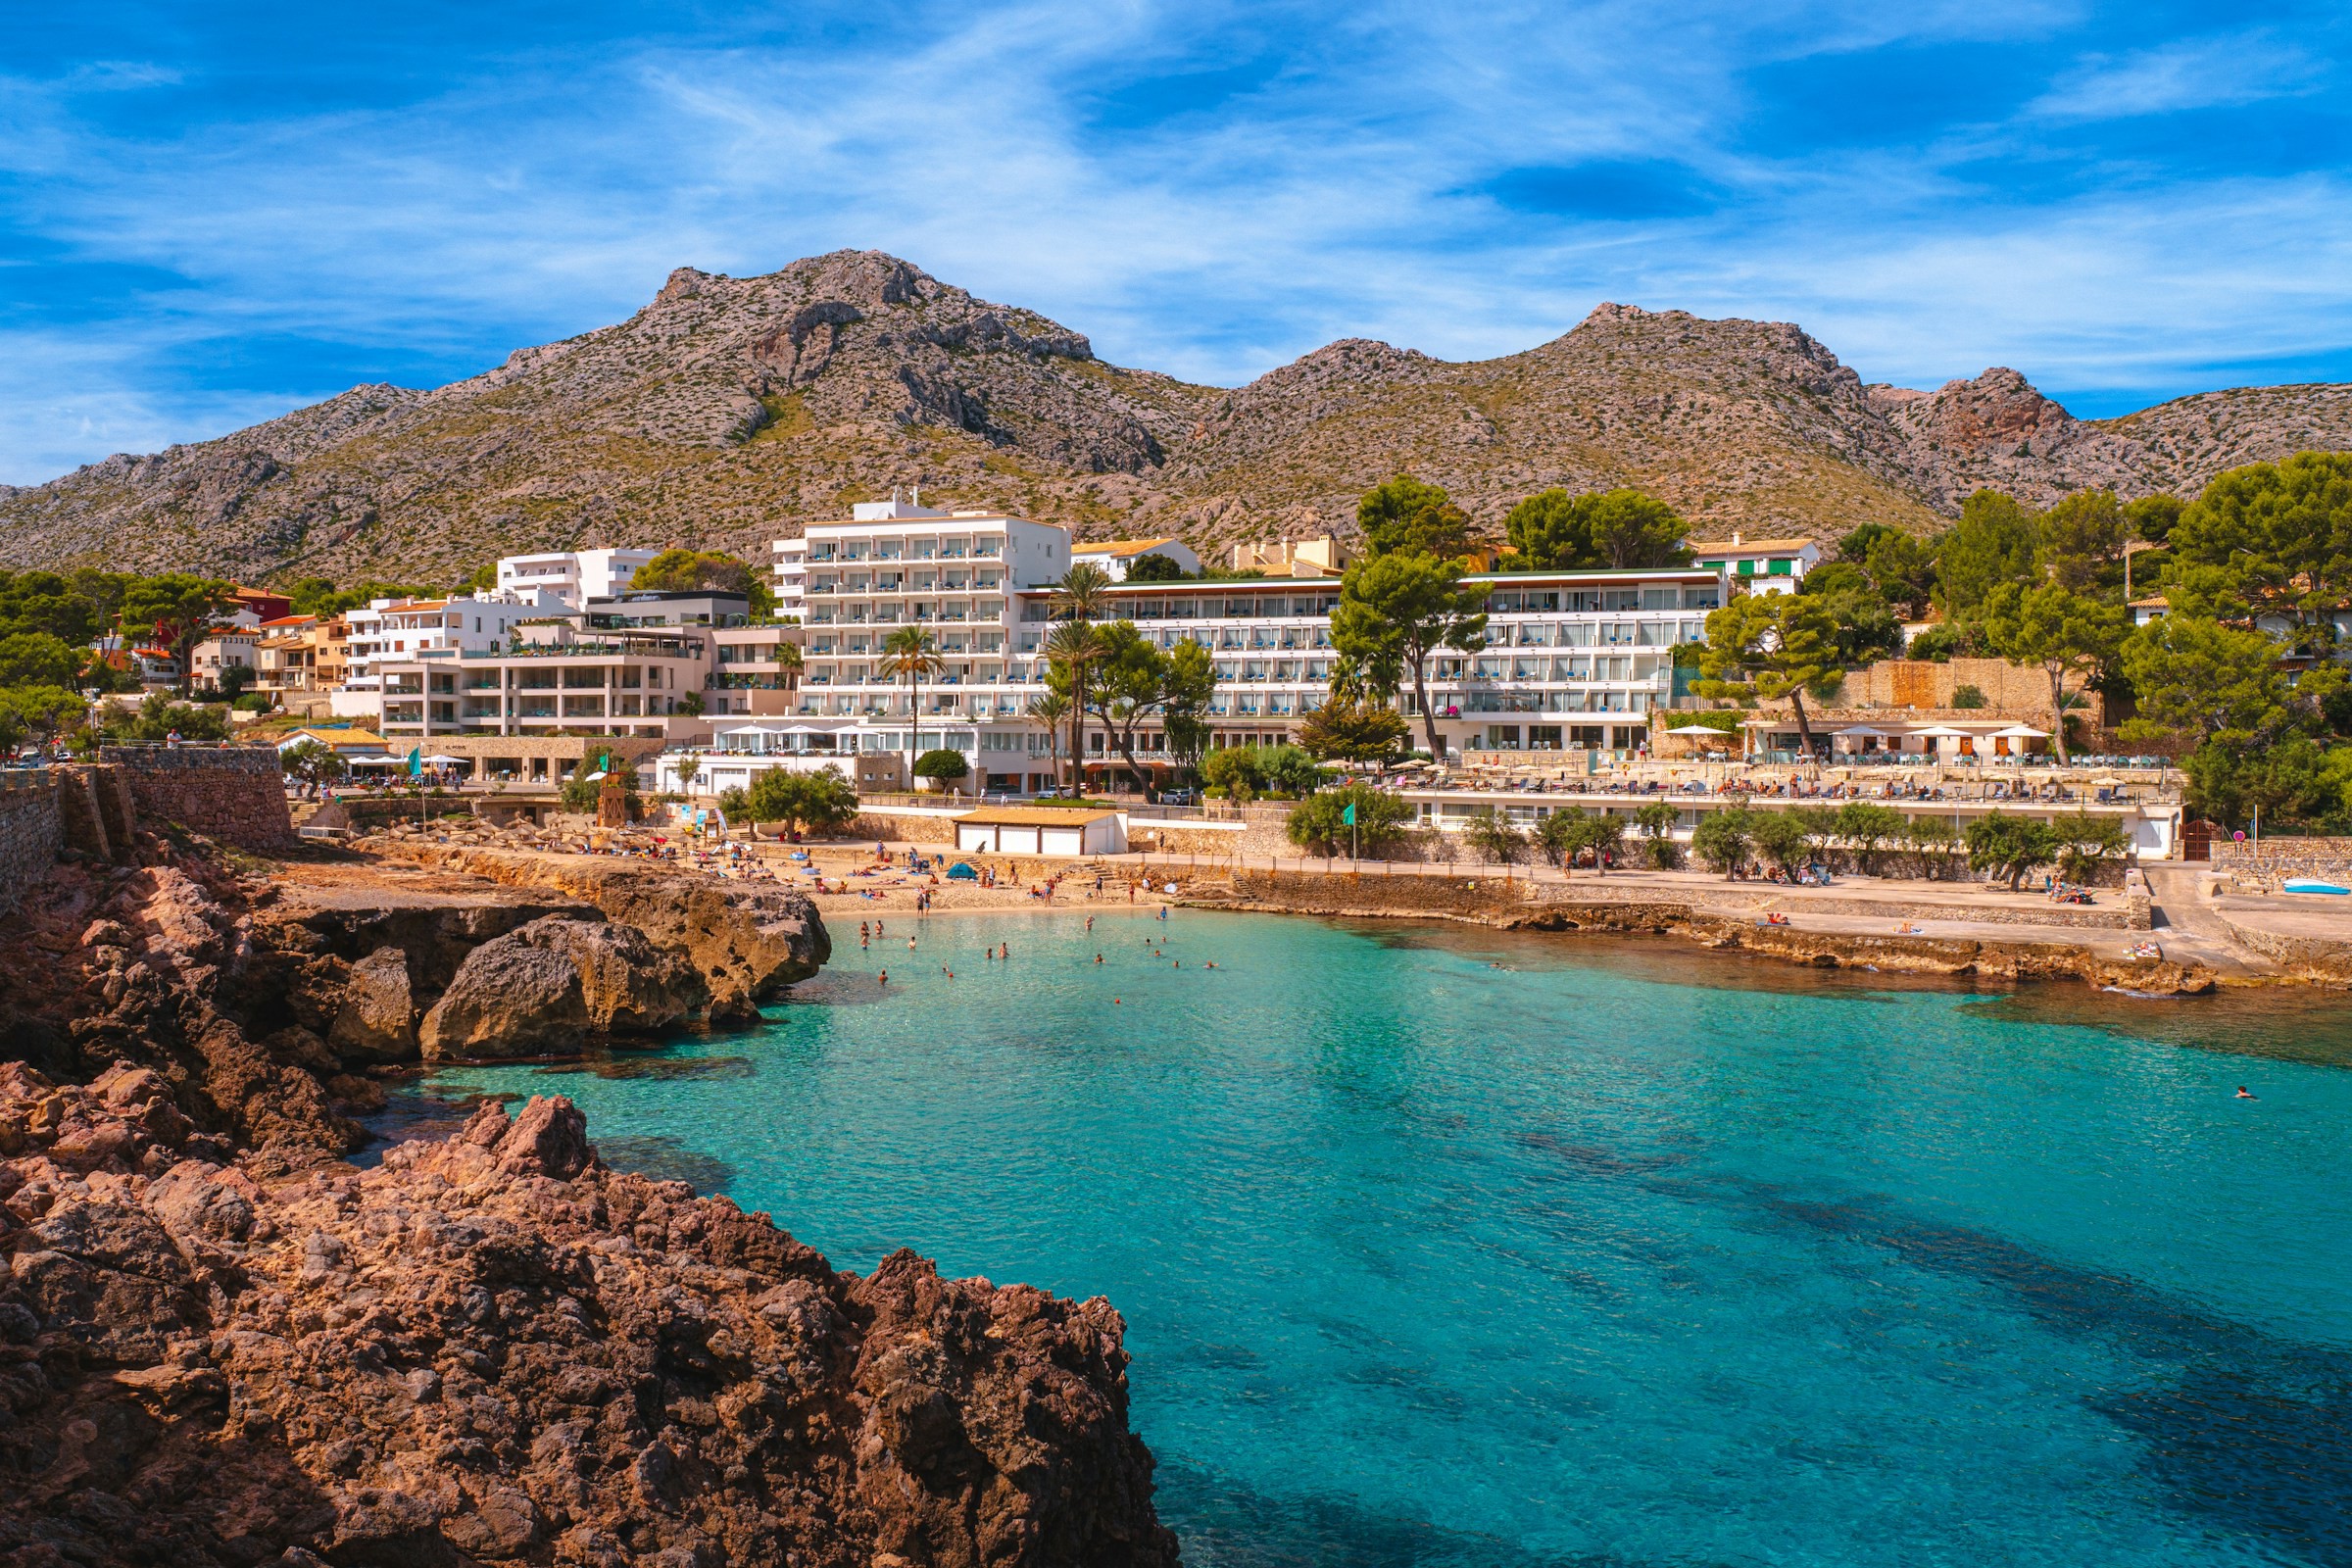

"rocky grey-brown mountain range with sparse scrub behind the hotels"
[0, 252, 2352, 578]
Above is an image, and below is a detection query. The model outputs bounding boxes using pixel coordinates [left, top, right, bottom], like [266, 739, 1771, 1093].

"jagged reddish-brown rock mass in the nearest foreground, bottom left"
[0, 1081, 1176, 1568]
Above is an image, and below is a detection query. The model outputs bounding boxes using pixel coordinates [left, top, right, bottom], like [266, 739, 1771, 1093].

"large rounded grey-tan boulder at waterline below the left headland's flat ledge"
[418, 917, 710, 1060]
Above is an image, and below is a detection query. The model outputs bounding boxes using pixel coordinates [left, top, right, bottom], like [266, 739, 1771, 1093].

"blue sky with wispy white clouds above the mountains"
[0, 0, 2352, 484]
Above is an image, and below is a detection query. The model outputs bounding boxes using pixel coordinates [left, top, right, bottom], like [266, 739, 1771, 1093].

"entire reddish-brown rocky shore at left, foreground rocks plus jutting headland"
[0, 835, 1176, 1568]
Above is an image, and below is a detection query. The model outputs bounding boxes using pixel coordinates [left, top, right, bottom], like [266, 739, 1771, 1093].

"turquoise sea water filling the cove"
[395, 909, 2352, 1568]
